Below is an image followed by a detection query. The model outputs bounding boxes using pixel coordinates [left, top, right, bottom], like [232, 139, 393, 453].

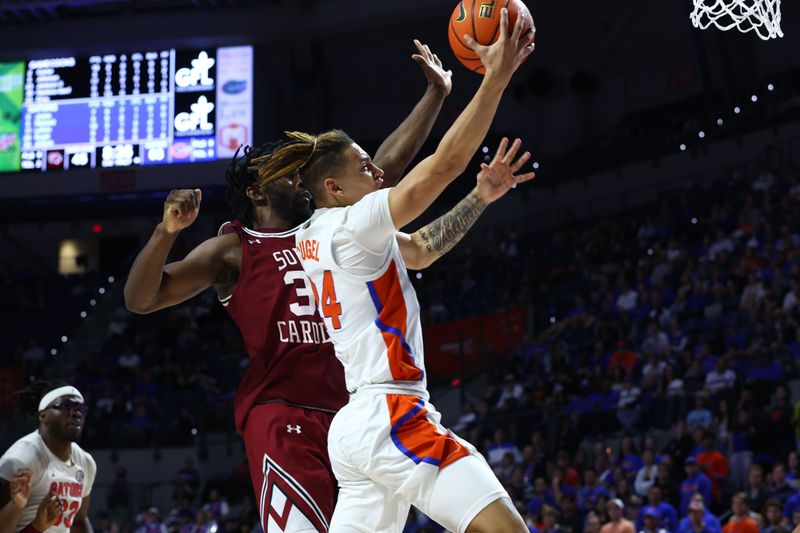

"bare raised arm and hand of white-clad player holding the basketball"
[389, 8, 534, 229]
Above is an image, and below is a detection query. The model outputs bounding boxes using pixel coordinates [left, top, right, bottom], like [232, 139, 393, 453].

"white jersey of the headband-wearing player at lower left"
[0, 430, 97, 533]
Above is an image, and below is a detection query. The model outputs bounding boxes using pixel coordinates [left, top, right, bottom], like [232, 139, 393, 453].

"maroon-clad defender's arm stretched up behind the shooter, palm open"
[375, 39, 453, 187]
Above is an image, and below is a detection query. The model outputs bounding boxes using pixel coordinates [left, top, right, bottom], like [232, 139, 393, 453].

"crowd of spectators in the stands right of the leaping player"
[406, 155, 800, 533]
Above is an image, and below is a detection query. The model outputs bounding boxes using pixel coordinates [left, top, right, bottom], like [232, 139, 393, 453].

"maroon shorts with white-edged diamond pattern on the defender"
[243, 403, 336, 533]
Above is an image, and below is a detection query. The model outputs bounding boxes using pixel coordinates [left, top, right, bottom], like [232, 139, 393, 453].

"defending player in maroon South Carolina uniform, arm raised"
[125, 41, 451, 533]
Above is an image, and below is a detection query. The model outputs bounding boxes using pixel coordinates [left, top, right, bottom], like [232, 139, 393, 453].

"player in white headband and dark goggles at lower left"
[0, 382, 97, 533]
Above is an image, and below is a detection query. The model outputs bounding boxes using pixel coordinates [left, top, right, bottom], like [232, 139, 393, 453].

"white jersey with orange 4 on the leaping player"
[296, 189, 427, 398]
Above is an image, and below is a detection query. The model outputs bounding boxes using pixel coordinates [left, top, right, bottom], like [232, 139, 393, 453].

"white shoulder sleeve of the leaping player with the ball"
[332, 189, 397, 275]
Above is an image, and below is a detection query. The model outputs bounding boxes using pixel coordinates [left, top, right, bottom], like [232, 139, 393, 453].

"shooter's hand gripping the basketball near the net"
[464, 8, 536, 83]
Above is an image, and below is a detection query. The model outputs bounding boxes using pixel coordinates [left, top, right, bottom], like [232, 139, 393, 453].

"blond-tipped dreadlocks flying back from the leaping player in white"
[252, 130, 353, 196]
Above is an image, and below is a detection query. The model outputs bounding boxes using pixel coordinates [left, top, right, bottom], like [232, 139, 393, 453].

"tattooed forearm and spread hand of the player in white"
[397, 138, 534, 270]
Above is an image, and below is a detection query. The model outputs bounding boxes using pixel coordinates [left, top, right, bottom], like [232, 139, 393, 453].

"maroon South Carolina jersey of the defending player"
[220, 221, 348, 434]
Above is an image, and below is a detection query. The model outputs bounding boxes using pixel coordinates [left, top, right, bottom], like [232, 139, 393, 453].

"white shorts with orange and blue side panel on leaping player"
[328, 394, 508, 533]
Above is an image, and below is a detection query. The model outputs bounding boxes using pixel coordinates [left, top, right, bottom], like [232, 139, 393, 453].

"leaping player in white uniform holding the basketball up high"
[254, 9, 534, 533]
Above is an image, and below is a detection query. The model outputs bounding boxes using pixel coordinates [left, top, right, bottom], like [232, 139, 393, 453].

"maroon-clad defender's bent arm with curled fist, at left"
[124, 189, 233, 313]
